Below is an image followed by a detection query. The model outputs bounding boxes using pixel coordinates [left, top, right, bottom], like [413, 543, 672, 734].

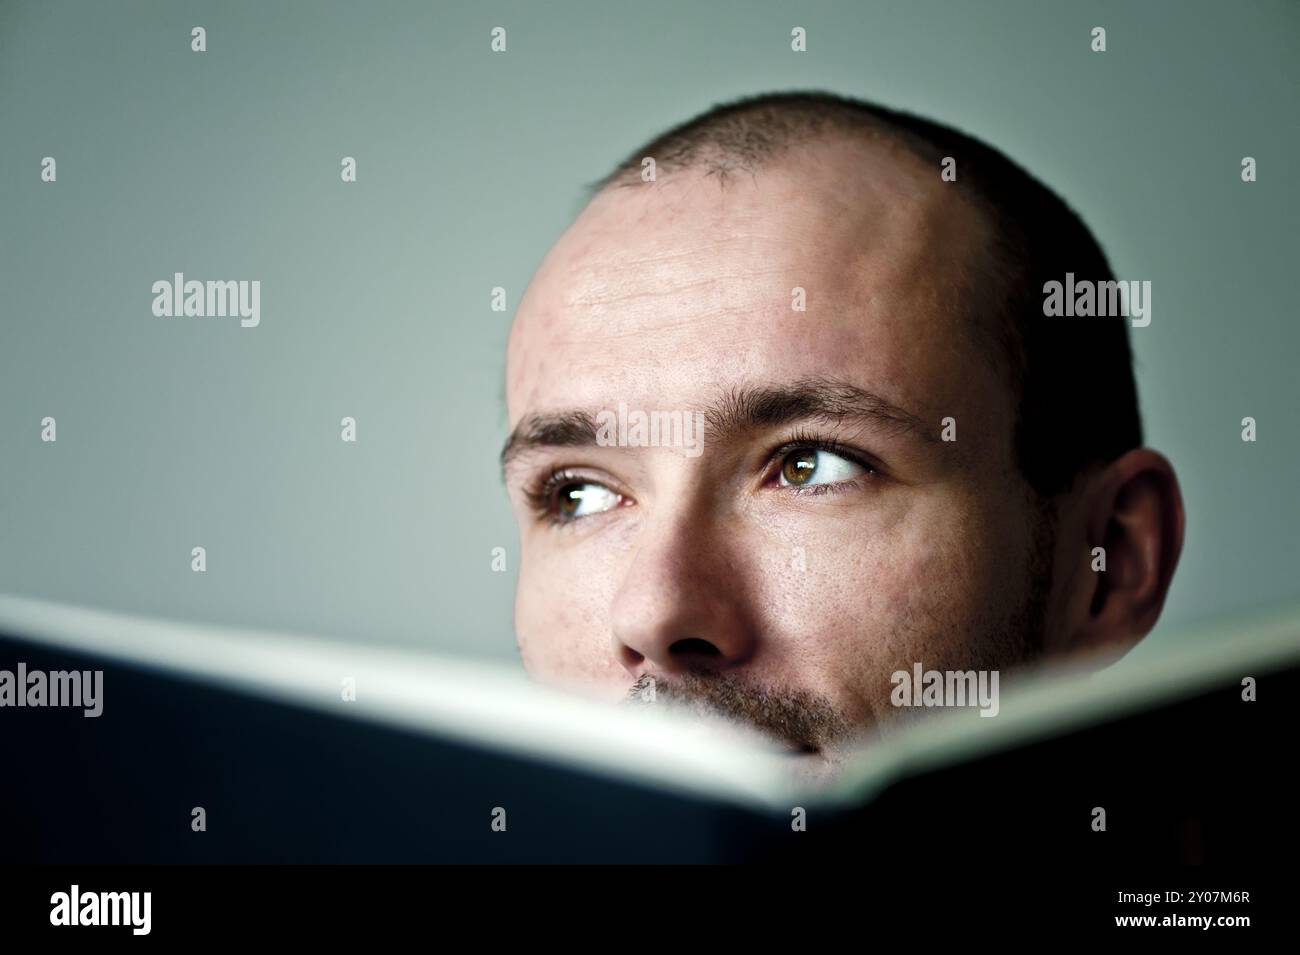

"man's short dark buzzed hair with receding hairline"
[593, 92, 1143, 496]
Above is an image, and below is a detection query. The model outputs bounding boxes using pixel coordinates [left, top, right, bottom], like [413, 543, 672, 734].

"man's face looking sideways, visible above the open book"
[506, 134, 1041, 779]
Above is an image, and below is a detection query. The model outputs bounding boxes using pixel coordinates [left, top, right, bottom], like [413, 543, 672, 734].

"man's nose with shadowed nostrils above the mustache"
[610, 513, 757, 677]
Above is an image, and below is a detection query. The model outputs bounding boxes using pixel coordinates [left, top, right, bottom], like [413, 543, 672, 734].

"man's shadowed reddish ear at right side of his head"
[1061, 448, 1186, 659]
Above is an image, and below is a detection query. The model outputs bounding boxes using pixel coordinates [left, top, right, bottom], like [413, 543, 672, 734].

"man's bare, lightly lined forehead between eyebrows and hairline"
[507, 134, 1006, 426]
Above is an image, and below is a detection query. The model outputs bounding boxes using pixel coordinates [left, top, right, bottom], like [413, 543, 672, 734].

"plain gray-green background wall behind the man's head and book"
[0, 0, 1300, 659]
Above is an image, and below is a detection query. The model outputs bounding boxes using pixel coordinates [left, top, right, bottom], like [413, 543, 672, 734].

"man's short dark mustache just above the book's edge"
[624, 672, 852, 751]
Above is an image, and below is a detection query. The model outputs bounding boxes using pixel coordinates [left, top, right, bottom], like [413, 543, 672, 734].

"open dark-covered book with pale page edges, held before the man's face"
[0, 596, 1300, 863]
